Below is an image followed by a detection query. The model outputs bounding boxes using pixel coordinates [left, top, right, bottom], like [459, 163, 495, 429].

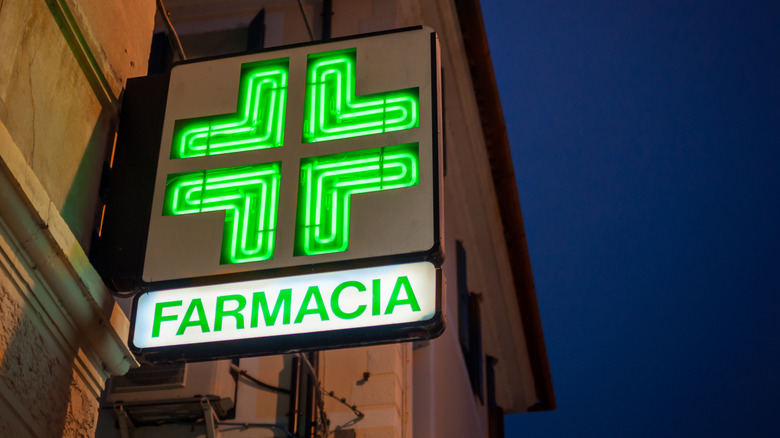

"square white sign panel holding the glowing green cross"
[142, 28, 441, 284]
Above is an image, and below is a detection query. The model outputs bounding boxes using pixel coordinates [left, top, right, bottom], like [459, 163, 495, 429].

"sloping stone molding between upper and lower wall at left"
[0, 122, 137, 390]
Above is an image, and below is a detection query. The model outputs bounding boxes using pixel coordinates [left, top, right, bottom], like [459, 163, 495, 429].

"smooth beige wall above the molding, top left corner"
[0, 0, 154, 248]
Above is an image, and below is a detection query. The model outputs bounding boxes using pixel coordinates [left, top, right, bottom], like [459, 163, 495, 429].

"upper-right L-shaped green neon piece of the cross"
[303, 49, 420, 143]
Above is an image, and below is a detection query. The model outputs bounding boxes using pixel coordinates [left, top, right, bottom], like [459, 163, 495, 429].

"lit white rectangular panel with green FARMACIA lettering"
[132, 262, 437, 350]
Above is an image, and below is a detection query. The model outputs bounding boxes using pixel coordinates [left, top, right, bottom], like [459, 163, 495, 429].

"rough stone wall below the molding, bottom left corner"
[0, 199, 102, 437]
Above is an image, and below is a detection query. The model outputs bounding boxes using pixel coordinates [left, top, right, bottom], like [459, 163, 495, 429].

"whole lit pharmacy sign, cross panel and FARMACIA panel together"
[132, 28, 443, 360]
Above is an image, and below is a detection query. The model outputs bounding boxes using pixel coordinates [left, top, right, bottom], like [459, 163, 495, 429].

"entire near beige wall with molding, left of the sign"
[0, 0, 154, 437]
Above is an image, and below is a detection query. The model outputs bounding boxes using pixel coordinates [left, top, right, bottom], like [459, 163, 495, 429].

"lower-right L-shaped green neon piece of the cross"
[294, 143, 419, 256]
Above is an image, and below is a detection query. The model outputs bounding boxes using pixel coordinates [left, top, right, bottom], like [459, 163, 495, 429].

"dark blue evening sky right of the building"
[483, 0, 780, 437]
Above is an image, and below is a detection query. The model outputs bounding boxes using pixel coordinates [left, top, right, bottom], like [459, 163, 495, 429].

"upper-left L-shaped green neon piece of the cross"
[171, 58, 289, 159]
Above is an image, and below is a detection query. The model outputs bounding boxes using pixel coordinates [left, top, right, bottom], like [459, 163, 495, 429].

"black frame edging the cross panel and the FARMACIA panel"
[115, 26, 445, 362]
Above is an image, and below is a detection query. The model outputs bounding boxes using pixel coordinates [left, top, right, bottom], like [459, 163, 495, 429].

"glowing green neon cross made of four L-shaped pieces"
[163, 49, 419, 264]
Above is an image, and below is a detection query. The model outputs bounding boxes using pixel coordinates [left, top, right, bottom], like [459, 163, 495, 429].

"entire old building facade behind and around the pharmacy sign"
[0, 0, 555, 438]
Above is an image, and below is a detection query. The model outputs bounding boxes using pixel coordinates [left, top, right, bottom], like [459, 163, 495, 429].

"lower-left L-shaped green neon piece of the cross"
[163, 162, 281, 264]
